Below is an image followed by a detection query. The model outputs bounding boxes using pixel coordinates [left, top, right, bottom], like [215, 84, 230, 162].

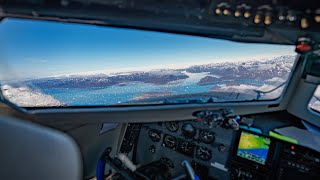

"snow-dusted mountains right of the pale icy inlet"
[187, 56, 295, 85]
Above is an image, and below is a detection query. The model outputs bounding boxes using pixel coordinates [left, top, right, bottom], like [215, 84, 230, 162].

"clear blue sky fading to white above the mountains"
[0, 19, 294, 78]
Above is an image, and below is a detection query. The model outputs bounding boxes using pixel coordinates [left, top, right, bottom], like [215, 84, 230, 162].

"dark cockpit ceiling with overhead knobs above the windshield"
[0, 0, 320, 47]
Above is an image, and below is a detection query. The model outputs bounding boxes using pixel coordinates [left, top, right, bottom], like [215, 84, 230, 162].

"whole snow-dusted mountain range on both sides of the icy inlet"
[24, 56, 295, 89]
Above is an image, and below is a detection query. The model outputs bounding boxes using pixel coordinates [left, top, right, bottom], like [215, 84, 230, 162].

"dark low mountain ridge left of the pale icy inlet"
[24, 70, 188, 89]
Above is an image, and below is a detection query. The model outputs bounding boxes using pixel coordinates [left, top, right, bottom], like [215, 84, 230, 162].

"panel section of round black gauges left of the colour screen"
[136, 120, 234, 179]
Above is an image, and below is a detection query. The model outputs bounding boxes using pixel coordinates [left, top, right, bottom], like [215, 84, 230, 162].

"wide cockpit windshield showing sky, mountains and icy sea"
[0, 19, 295, 107]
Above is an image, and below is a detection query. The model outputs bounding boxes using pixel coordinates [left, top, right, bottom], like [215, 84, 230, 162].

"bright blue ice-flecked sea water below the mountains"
[41, 72, 264, 106]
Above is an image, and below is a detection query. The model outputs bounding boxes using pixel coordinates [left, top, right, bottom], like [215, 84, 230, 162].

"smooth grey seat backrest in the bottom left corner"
[0, 115, 82, 180]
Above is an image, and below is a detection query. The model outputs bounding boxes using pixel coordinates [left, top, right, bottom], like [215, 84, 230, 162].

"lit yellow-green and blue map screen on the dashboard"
[237, 131, 271, 165]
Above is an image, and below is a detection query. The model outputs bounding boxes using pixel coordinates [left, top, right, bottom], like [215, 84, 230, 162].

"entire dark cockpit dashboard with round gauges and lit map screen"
[120, 112, 320, 179]
